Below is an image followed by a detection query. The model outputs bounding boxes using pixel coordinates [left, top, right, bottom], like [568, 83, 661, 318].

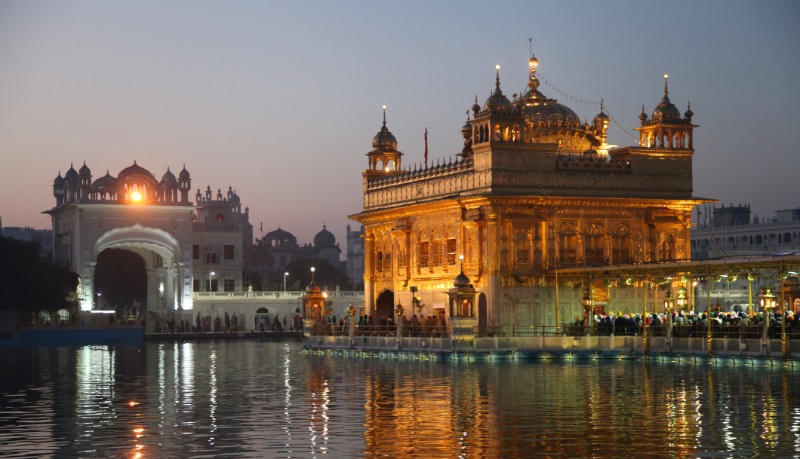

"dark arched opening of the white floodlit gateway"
[93, 249, 147, 323]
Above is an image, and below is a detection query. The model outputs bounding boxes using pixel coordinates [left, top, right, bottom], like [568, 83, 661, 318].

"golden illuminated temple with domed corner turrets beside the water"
[351, 51, 703, 333]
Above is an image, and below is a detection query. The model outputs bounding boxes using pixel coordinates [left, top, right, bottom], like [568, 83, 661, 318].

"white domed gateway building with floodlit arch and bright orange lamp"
[46, 161, 253, 312]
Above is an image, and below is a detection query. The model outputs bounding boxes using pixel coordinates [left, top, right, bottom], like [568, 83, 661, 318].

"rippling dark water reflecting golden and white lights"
[0, 341, 800, 458]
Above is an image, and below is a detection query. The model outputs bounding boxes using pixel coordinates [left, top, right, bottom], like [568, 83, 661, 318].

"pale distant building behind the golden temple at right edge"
[691, 205, 800, 260]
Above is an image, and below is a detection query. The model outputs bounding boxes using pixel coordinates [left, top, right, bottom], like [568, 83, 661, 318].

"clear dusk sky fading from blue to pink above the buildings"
[0, 0, 800, 250]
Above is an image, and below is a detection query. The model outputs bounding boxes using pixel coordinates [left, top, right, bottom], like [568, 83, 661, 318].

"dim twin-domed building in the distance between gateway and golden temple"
[251, 225, 345, 288]
